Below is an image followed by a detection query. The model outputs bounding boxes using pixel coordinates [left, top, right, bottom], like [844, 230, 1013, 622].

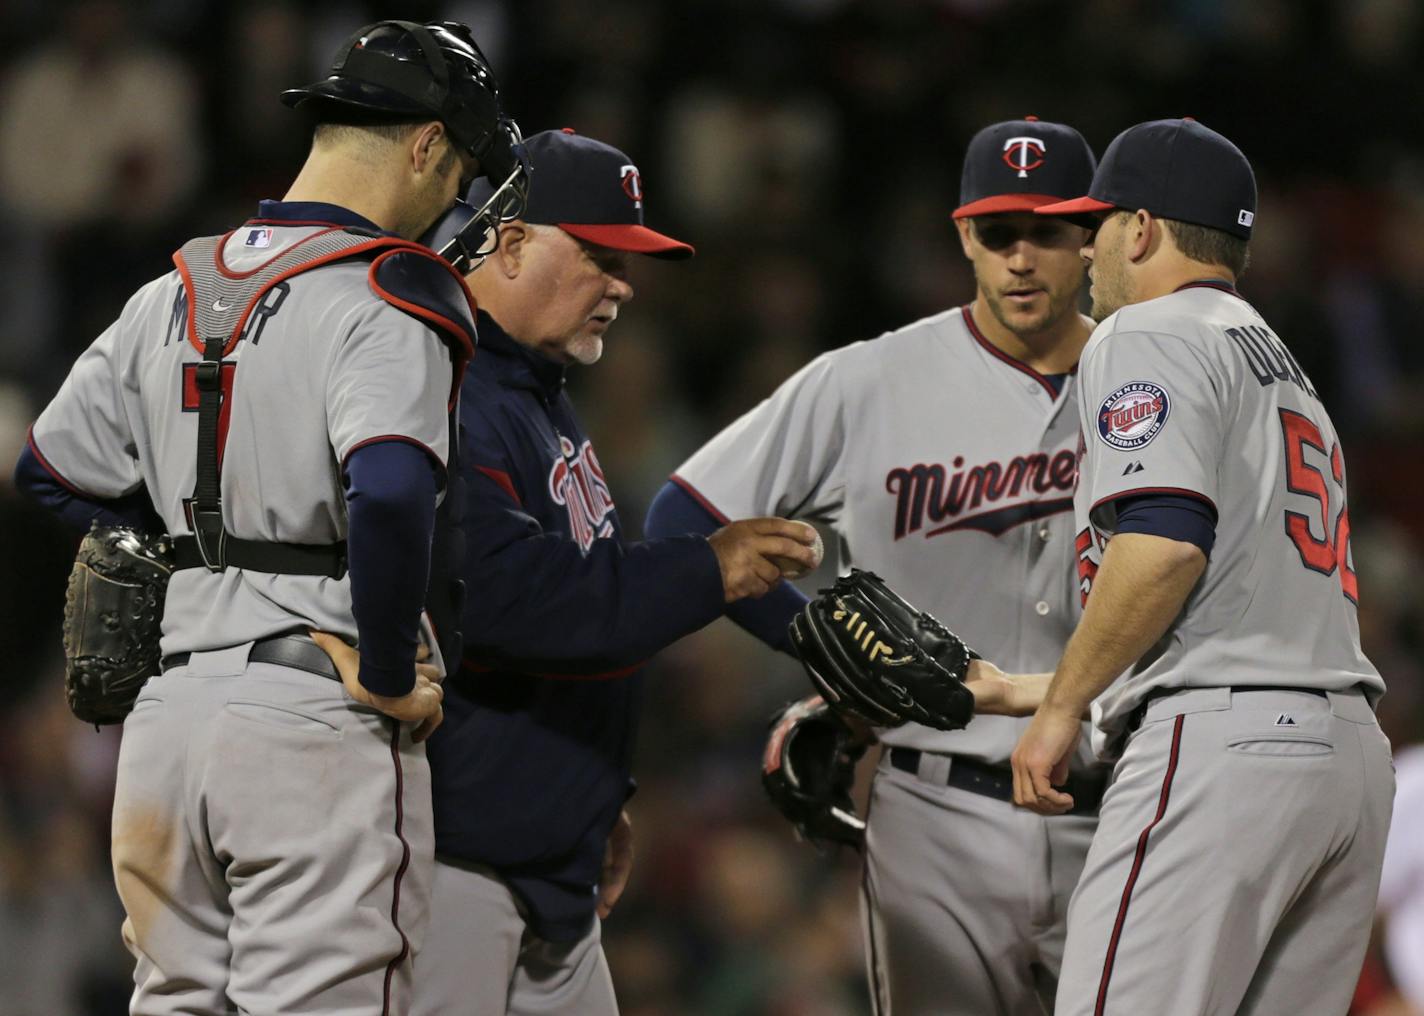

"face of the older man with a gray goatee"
[521, 227, 632, 366]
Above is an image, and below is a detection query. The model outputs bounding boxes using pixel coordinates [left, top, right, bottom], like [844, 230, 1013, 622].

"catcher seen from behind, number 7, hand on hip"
[17, 21, 518, 1015]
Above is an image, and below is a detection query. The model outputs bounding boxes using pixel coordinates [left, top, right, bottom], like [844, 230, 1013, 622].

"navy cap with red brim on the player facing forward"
[954, 117, 1098, 218]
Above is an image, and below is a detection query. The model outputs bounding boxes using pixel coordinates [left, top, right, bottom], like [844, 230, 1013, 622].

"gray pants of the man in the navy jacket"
[413, 859, 618, 1016]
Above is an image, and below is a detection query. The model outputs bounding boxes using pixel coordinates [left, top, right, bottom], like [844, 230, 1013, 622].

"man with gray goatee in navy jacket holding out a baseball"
[414, 131, 819, 1016]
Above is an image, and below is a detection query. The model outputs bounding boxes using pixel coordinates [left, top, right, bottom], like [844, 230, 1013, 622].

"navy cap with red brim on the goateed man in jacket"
[464, 127, 693, 259]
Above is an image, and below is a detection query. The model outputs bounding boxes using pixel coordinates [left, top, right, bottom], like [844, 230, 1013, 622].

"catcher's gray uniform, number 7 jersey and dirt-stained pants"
[33, 224, 453, 1015]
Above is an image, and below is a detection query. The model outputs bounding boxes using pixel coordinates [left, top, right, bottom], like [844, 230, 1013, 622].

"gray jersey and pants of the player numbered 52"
[1057, 282, 1394, 1016]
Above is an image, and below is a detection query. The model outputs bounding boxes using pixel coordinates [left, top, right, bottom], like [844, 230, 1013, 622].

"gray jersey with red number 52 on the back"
[1075, 284, 1384, 750]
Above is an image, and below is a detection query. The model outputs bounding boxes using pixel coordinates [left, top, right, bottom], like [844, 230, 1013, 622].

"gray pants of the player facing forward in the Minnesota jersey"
[862, 752, 1095, 1016]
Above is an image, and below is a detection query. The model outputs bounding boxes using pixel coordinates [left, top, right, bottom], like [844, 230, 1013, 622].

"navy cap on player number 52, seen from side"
[1034, 117, 1256, 239]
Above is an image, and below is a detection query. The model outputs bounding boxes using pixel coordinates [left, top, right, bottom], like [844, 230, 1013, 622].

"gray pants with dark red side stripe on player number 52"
[1058, 688, 1394, 1016]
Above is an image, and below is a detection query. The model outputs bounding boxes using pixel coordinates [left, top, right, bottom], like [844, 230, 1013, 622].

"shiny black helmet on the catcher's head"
[282, 21, 520, 188]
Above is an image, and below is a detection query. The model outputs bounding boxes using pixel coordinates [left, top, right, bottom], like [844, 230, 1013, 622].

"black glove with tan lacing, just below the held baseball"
[790, 569, 978, 730]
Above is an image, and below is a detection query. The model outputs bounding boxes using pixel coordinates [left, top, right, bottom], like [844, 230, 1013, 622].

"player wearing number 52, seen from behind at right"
[1012, 120, 1394, 1016]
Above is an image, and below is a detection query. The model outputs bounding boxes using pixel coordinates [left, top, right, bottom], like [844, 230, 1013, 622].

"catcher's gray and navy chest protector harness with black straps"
[172, 227, 474, 665]
